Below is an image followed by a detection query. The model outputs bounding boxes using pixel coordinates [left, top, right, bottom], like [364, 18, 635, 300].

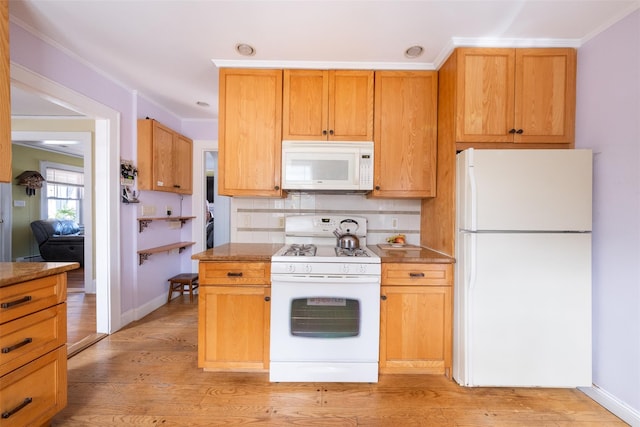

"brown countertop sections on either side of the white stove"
[191, 243, 455, 264]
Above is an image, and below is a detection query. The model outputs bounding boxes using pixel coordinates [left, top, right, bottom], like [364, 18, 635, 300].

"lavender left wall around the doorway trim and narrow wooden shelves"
[10, 18, 214, 324]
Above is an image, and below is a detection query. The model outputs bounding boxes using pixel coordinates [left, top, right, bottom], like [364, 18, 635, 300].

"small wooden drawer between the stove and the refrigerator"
[382, 263, 453, 286]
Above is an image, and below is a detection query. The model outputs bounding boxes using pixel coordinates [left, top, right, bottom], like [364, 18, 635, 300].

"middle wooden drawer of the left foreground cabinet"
[0, 303, 67, 376]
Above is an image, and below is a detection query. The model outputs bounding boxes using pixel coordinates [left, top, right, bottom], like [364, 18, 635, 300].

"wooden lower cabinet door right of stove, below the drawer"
[380, 286, 452, 374]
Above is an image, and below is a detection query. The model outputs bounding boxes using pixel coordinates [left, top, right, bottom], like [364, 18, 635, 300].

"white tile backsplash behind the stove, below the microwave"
[230, 193, 421, 245]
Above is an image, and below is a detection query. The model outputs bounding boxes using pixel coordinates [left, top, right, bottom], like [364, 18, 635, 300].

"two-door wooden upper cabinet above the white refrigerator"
[456, 48, 576, 144]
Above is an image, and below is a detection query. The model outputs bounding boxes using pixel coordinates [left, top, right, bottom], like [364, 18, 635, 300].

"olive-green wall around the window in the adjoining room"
[11, 144, 83, 259]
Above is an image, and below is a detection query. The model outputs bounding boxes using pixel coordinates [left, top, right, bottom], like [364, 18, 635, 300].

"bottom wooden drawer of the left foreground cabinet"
[0, 346, 67, 427]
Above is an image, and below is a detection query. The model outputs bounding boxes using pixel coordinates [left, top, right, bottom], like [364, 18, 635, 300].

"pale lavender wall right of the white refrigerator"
[576, 11, 640, 425]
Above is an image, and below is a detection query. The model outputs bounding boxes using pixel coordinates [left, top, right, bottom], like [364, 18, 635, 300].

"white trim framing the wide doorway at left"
[10, 62, 124, 333]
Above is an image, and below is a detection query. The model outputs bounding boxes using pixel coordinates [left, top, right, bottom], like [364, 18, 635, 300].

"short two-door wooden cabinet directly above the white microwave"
[282, 70, 374, 141]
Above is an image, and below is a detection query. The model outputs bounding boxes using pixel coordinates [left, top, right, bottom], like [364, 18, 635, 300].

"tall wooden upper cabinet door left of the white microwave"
[218, 68, 282, 197]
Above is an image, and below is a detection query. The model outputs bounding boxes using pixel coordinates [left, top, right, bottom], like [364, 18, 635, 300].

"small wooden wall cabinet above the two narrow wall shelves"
[138, 119, 193, 194]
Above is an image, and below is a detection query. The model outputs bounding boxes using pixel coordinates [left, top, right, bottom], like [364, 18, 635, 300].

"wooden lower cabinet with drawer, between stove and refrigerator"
[380, 263, 453, 377]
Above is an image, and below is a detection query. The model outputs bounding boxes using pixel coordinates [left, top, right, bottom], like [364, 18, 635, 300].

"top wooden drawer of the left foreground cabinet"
[0, 273, 67, 323]
